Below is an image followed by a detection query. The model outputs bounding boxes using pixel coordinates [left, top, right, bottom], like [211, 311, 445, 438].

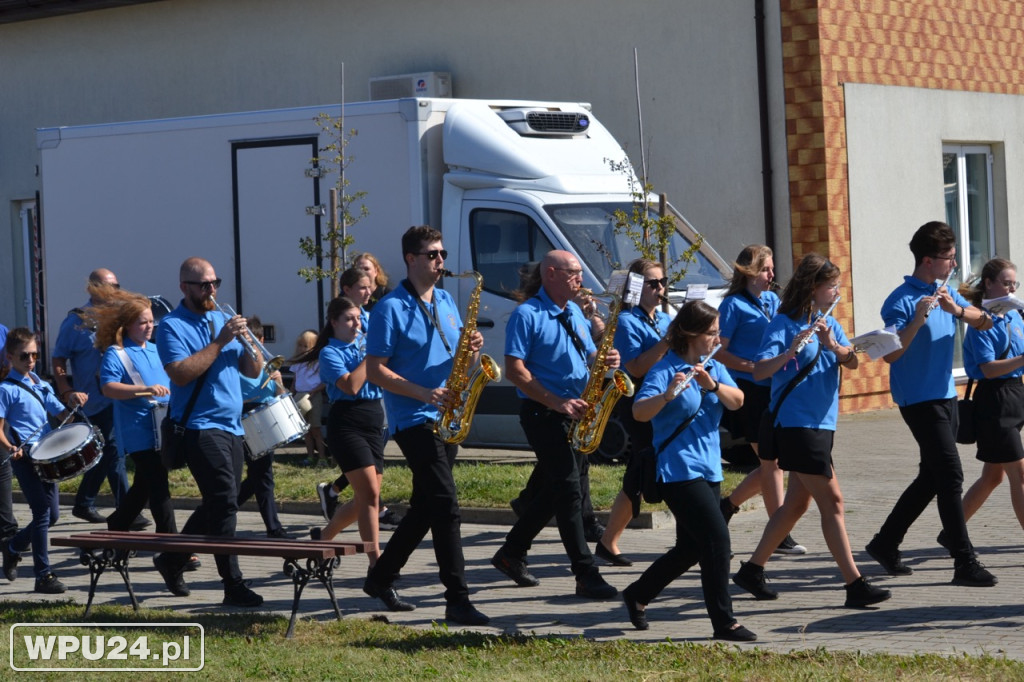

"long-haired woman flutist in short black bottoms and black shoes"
[732, 253, 891, 606]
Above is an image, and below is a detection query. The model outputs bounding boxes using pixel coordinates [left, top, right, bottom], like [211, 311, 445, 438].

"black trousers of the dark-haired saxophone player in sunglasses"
[367, 422, 469, 604]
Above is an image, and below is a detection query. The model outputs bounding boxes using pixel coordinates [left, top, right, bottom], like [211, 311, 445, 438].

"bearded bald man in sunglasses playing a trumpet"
[154, 258, 263, 606]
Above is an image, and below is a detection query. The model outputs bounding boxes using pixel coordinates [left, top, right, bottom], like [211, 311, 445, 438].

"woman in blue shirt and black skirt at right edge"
[954, 258, 1024, 532]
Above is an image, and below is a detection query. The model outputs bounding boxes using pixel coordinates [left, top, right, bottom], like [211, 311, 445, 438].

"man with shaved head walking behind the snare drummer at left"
[53, 267, 133, 522]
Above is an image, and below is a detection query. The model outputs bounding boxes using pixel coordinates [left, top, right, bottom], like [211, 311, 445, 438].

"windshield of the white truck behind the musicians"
[545, 202, 731, 289]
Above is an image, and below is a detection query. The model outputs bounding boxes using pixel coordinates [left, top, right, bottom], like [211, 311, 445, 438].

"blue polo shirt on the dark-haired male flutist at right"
[882, 275, 971, 408]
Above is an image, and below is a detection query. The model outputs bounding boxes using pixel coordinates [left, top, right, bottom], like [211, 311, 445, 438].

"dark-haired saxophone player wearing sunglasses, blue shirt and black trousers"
[362, 225, 489, 625]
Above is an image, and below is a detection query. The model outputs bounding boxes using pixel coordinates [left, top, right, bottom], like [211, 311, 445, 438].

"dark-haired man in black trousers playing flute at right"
[866, 221, 997, 587]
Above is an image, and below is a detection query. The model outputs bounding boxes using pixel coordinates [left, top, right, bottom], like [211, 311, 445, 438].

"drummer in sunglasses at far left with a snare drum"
[0, 327, 79, 594]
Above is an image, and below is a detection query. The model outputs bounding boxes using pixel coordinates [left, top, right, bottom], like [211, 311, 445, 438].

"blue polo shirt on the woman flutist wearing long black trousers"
[634, 352, 736, 483]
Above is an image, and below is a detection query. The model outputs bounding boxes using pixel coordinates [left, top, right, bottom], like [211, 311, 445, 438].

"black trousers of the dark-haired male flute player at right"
[879, 397, 974, 561]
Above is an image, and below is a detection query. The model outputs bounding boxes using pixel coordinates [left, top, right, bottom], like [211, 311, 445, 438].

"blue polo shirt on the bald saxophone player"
[505, 287, 597, 398]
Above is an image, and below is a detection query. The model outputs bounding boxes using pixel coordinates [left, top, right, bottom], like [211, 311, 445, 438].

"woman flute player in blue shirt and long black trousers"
[623, 301, 757, 642]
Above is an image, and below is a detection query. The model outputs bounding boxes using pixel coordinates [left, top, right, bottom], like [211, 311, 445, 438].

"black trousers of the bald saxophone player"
[505, 400, 594, 578]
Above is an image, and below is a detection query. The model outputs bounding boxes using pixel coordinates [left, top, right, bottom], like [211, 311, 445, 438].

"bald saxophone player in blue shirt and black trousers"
[490, 251, 618, 599]
